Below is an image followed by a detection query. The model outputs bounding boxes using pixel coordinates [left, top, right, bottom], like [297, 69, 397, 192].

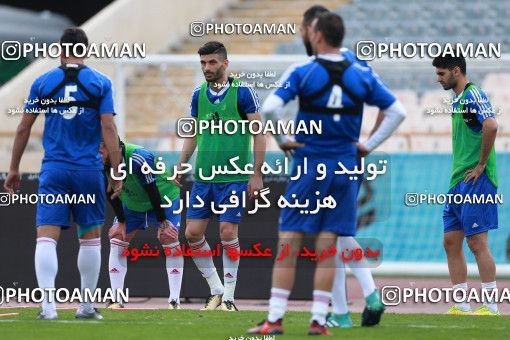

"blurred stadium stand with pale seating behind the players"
[0, 0, 510, 170]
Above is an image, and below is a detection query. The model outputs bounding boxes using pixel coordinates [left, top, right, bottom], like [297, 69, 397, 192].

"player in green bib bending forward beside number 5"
[100, 141, 184, 309]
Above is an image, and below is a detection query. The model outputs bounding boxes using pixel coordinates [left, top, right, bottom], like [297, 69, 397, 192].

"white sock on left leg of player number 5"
[35, 237, 58, 314]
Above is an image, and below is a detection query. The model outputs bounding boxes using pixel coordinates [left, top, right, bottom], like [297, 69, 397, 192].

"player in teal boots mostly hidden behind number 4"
[298, 5, 390, 328]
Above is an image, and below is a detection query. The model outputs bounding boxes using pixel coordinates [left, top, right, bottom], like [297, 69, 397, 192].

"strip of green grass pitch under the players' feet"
[0, 308, 510, 340]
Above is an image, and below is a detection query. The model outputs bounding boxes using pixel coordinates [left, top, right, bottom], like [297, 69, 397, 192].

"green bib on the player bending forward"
[120, 143, 180, 212]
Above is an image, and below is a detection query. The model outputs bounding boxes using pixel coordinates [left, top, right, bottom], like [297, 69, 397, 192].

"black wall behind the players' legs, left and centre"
[0, 177, 314, 299]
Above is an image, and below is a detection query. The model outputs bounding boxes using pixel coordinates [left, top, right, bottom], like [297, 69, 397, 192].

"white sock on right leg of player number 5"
[78, 238, 101, 310]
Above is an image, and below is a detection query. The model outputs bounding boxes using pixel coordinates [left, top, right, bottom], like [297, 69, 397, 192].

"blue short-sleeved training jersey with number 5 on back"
[25, 64, 115, 170]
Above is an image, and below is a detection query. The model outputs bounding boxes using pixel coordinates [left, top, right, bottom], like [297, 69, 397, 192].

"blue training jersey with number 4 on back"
[274, 50, 396, 158]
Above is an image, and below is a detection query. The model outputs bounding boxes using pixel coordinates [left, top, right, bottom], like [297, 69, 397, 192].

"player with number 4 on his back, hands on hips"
[248, 13, 405, 335]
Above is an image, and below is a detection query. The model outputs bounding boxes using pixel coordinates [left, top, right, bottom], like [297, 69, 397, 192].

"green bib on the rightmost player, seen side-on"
[450, 85, 498, 189]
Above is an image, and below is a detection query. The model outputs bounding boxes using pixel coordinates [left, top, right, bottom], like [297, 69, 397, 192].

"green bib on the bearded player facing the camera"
[195, 79, 251, 183]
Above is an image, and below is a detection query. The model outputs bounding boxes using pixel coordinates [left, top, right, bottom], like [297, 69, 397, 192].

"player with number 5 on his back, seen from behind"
[4, 28, 122, 320]
